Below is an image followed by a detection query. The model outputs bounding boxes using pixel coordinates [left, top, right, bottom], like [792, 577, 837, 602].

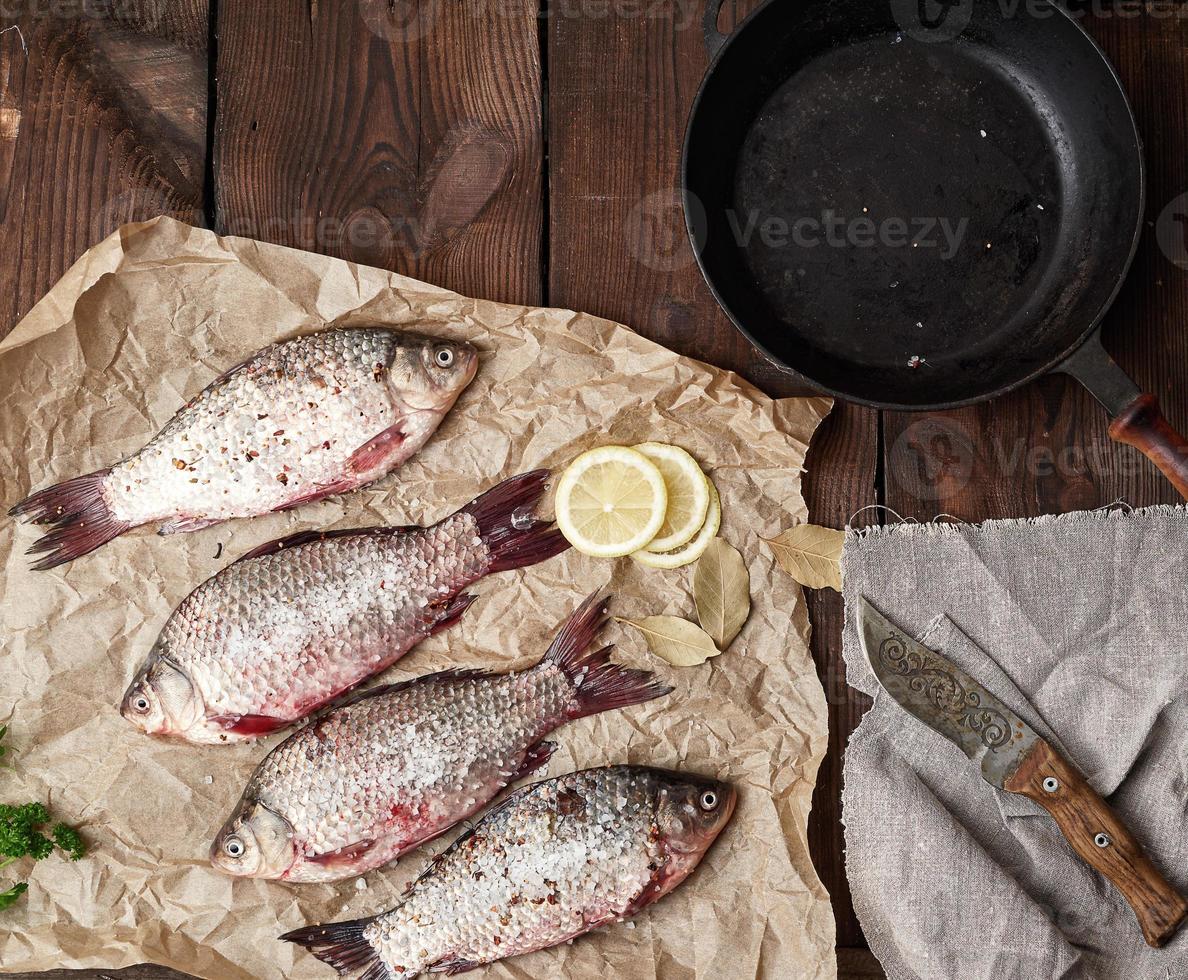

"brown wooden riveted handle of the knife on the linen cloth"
[1004, 740, 1188, 947]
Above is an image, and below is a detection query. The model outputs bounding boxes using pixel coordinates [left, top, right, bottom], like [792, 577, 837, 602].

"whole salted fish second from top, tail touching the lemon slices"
[120, 470, 567, 742]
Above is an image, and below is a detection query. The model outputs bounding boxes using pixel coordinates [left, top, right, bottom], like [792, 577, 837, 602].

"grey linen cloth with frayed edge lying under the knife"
[843, 507, 1188, 980]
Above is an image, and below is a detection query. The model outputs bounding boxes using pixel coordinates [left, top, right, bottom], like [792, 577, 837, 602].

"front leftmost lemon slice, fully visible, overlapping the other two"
[554, 445, 668, 558]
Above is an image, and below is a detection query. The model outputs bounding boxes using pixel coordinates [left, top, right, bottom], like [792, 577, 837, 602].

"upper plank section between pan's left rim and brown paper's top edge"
[549, 0, 791, 393]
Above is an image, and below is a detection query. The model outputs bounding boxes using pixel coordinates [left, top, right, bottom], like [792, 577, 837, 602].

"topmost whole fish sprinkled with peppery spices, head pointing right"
[10, 327, 478, 569]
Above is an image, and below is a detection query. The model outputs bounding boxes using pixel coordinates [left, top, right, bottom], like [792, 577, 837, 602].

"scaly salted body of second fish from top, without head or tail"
[166, 516, 491, 716]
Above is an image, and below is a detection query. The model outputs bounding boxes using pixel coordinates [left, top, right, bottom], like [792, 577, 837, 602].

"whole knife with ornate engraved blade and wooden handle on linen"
[858, 598, 1188, 947]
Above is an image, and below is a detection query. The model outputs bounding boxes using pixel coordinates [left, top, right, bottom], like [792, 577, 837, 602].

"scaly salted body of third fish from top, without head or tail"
[258, 664, 576, 880]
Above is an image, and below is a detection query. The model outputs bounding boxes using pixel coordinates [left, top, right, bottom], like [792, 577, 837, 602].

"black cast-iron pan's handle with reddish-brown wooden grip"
[1060, 336, 1188, 499]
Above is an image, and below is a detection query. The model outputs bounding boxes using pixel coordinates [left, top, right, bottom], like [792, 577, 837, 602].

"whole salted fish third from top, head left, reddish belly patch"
[210, 595, 671, 881]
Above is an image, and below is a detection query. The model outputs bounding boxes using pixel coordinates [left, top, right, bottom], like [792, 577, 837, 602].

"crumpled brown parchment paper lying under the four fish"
[0, 219, 835, 980]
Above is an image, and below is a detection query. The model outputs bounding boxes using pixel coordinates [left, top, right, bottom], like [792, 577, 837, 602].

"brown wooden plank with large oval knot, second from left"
[214, 0, 543, 303]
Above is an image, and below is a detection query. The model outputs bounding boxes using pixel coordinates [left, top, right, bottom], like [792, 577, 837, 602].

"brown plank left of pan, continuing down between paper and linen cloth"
[548, 0, 878, 946]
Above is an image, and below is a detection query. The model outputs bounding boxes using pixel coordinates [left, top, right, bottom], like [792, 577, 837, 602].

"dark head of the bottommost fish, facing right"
[650, 772, 738, 900]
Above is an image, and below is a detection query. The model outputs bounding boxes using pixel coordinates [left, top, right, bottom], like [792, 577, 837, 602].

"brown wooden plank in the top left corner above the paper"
[0, 0, 207, 336]
